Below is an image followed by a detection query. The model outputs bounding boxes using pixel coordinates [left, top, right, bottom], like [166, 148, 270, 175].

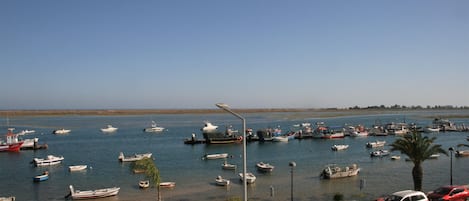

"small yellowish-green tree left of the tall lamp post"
[131, 158, 161, 201]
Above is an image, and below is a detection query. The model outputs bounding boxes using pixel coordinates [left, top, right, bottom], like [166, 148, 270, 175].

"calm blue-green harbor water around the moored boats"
[0, 111, 469, 201]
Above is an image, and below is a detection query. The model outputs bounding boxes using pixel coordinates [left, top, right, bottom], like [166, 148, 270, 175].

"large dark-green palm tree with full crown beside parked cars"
[391, 131, 448, 191]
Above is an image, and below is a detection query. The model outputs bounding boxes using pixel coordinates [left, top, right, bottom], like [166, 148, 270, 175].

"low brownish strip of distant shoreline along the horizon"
[0, 108, 469, 118]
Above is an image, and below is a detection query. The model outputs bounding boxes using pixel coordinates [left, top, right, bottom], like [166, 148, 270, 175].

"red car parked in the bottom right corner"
[427, 186, 469, 201]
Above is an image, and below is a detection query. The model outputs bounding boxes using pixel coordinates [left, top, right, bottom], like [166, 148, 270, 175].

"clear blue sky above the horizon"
[0, 0, 469, 109]
